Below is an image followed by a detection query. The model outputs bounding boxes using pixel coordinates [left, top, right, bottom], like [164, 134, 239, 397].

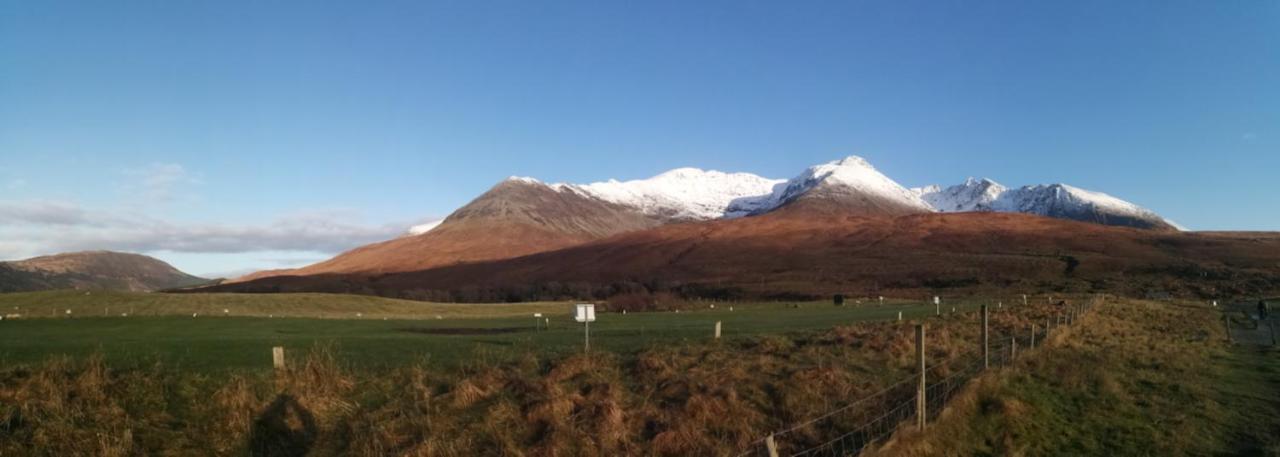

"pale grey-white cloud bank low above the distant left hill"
[0, 164, 436, 277]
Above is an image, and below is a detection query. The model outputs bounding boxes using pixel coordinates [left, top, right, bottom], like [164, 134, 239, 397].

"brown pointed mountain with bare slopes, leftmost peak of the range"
[237, 179, 660, 277]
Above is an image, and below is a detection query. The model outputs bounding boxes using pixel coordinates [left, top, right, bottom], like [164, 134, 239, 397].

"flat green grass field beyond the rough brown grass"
[0, 292, 1003, 371]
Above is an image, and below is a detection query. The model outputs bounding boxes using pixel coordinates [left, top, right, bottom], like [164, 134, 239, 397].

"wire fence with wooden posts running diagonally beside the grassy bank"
[737, 295, 1097, 457]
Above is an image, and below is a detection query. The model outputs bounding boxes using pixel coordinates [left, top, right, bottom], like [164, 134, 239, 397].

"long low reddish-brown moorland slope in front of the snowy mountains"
[197, 210, 1280, 301]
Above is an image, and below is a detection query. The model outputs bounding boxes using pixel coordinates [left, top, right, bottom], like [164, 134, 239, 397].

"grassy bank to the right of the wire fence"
[879, 296, 1280, 456]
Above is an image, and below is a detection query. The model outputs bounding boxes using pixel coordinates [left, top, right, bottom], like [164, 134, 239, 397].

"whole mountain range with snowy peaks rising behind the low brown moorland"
[238, 156, 1176, 277]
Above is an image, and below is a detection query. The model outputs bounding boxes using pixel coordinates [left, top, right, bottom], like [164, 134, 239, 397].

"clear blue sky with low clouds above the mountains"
[0, 0, 1280, 274]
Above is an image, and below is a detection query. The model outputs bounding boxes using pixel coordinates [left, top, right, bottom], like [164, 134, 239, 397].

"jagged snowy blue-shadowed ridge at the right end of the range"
[911, 178, 1180, 229]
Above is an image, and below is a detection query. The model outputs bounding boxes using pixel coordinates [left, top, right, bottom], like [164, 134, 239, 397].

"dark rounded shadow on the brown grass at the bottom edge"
[248, 393, 319, 456]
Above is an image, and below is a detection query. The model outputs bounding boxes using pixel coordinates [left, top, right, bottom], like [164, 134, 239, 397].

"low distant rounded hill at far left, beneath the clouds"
[0, 251, 209, 292]
